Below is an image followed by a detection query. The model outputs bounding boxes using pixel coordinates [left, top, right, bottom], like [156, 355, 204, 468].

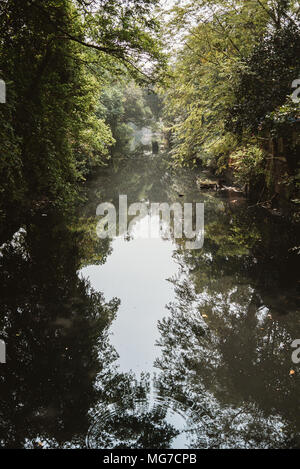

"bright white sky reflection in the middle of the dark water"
[82, 213, 178, 373]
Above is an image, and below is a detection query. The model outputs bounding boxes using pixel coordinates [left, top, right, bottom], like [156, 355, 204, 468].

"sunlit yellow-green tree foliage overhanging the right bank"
[165, 0, 300, 204]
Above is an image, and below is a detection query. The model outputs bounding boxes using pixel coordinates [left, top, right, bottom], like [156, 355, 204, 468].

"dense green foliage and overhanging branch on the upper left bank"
[0, 0, 163, 225]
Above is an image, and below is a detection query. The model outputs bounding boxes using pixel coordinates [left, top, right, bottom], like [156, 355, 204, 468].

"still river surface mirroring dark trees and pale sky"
[0, 155, 300, 448]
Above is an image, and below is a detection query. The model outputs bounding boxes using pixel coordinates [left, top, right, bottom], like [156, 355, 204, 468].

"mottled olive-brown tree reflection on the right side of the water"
[156, 204, 300, 448]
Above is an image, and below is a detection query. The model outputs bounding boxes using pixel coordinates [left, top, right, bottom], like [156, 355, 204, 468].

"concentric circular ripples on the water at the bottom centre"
[86, 395, 208, 449]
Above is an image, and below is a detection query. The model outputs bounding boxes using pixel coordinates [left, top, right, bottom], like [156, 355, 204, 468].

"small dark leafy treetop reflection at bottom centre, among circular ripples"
[88, 373, 179, 449]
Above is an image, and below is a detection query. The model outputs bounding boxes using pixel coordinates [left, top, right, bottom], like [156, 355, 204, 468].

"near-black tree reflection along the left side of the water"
[0, 215, 118, 447]
